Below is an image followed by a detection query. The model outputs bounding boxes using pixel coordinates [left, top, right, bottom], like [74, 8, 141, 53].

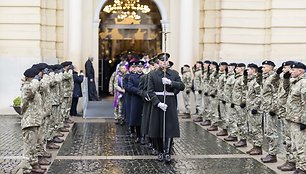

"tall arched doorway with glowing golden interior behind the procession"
[98, 0, 162, 96]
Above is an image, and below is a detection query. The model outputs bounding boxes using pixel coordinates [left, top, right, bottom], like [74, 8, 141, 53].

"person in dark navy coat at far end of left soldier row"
[70, 67, 84, 116]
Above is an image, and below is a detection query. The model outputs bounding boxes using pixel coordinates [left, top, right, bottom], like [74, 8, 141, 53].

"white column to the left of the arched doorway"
[68, 0, 83, 68]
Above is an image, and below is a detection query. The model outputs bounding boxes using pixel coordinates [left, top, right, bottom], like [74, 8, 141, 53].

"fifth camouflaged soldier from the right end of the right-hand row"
[226, 63, 248, 147]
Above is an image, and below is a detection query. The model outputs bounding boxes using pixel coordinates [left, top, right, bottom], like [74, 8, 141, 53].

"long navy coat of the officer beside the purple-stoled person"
[127, 73, 143, 126]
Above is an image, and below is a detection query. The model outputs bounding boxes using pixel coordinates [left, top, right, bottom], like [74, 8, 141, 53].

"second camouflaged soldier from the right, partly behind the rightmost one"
[276, 61, 295, 171]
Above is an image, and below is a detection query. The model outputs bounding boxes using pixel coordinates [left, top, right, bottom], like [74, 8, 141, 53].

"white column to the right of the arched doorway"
[178, 0, 194, 67]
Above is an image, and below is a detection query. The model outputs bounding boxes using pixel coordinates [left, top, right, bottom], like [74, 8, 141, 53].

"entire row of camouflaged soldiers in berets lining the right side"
[181, 60, 306, 174]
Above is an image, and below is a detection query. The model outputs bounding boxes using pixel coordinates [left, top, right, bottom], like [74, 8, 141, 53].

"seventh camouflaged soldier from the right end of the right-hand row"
[216, 62, 228, 136]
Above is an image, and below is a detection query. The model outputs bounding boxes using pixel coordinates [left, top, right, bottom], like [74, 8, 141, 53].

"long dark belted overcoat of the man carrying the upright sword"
[148, 69, 185, 138]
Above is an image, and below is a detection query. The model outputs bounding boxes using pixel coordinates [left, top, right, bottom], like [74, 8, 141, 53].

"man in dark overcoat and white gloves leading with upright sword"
[148, 53, 185, 164]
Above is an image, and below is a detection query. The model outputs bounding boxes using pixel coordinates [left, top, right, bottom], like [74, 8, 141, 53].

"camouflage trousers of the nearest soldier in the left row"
[22, 127, 39, 173]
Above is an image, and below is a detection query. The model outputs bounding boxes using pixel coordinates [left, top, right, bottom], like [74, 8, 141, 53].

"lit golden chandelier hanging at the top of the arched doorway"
[103, 0, 150, 20]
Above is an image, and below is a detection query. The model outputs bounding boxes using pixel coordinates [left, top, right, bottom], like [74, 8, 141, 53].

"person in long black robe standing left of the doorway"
[85, 57, 99, 101]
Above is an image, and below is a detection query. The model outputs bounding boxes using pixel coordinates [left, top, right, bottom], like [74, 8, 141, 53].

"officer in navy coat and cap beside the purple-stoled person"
[127, 61, 144, 143]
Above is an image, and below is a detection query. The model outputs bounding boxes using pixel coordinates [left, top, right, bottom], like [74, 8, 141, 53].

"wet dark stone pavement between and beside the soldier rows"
[0, 116, 292, 174]
